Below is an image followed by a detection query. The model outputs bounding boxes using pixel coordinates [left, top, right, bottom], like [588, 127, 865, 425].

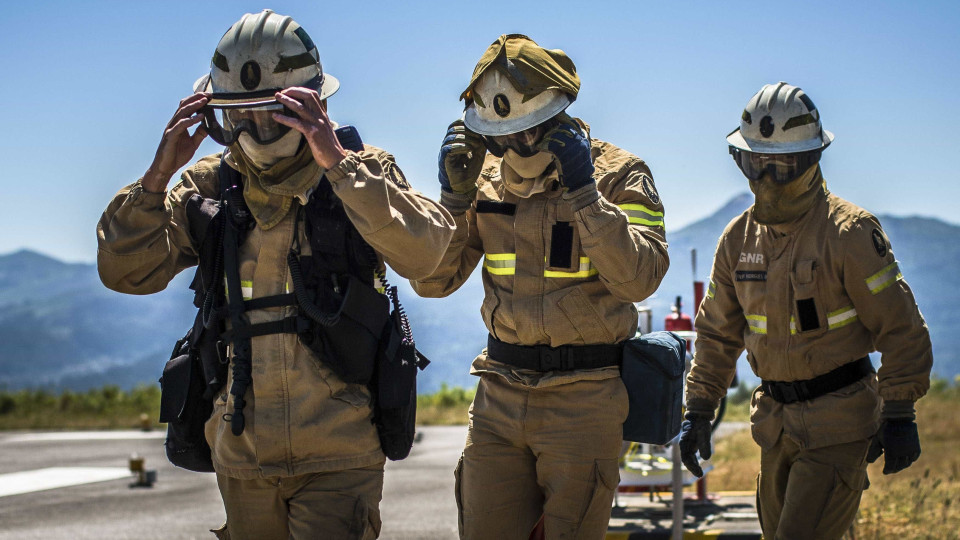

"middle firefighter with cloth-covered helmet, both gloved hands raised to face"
[412, 34, 668, 539]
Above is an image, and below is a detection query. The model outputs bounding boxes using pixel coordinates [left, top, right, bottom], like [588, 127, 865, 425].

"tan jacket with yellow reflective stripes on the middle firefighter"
[412, 135, 669, 386]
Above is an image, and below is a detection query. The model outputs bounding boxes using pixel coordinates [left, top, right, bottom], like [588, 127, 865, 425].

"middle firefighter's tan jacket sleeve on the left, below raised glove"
[410, 193, 483, 298]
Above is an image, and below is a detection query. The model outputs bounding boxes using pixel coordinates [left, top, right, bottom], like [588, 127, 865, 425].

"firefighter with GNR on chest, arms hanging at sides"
[680, 82, 933, 539]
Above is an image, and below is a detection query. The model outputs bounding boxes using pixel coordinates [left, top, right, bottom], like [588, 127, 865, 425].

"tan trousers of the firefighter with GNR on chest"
[757, 434, 870, 540]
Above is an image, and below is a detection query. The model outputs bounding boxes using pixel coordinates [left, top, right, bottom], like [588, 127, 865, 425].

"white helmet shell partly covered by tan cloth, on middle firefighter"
[463, 69, 573, 136]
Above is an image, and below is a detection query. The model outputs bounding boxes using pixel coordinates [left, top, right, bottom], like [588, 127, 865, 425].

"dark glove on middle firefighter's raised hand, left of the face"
[437, 120, 487, 196]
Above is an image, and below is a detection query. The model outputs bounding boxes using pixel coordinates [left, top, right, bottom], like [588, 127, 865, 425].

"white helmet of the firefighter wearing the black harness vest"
[194, 9, 340, 107]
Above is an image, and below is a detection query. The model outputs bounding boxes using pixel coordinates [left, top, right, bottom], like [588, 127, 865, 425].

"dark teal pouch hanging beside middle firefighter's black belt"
[620, 332, 687, 445]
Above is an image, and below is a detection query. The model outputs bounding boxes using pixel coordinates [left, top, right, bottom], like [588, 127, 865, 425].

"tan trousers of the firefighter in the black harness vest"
[217, 463, 383, 540]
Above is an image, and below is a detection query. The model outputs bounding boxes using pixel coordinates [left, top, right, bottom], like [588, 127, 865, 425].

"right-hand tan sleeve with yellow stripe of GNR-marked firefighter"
[841, 213, 933, 401]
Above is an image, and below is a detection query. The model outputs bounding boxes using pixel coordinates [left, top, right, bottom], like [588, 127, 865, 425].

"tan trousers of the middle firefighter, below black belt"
[456, 373, 628, 540]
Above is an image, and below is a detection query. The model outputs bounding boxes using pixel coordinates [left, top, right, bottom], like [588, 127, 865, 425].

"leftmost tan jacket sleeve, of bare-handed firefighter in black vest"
[97, 156, 219, 294]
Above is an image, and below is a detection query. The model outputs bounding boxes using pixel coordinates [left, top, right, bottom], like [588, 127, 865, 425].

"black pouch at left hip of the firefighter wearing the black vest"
[160, 328, 214, 472]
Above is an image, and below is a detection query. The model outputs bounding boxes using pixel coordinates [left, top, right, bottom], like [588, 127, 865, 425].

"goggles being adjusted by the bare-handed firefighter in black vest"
[203, 101, 295, 146]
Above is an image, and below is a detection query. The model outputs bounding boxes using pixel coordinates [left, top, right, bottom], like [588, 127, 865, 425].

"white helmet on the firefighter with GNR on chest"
[727, 82, 833, 154]
